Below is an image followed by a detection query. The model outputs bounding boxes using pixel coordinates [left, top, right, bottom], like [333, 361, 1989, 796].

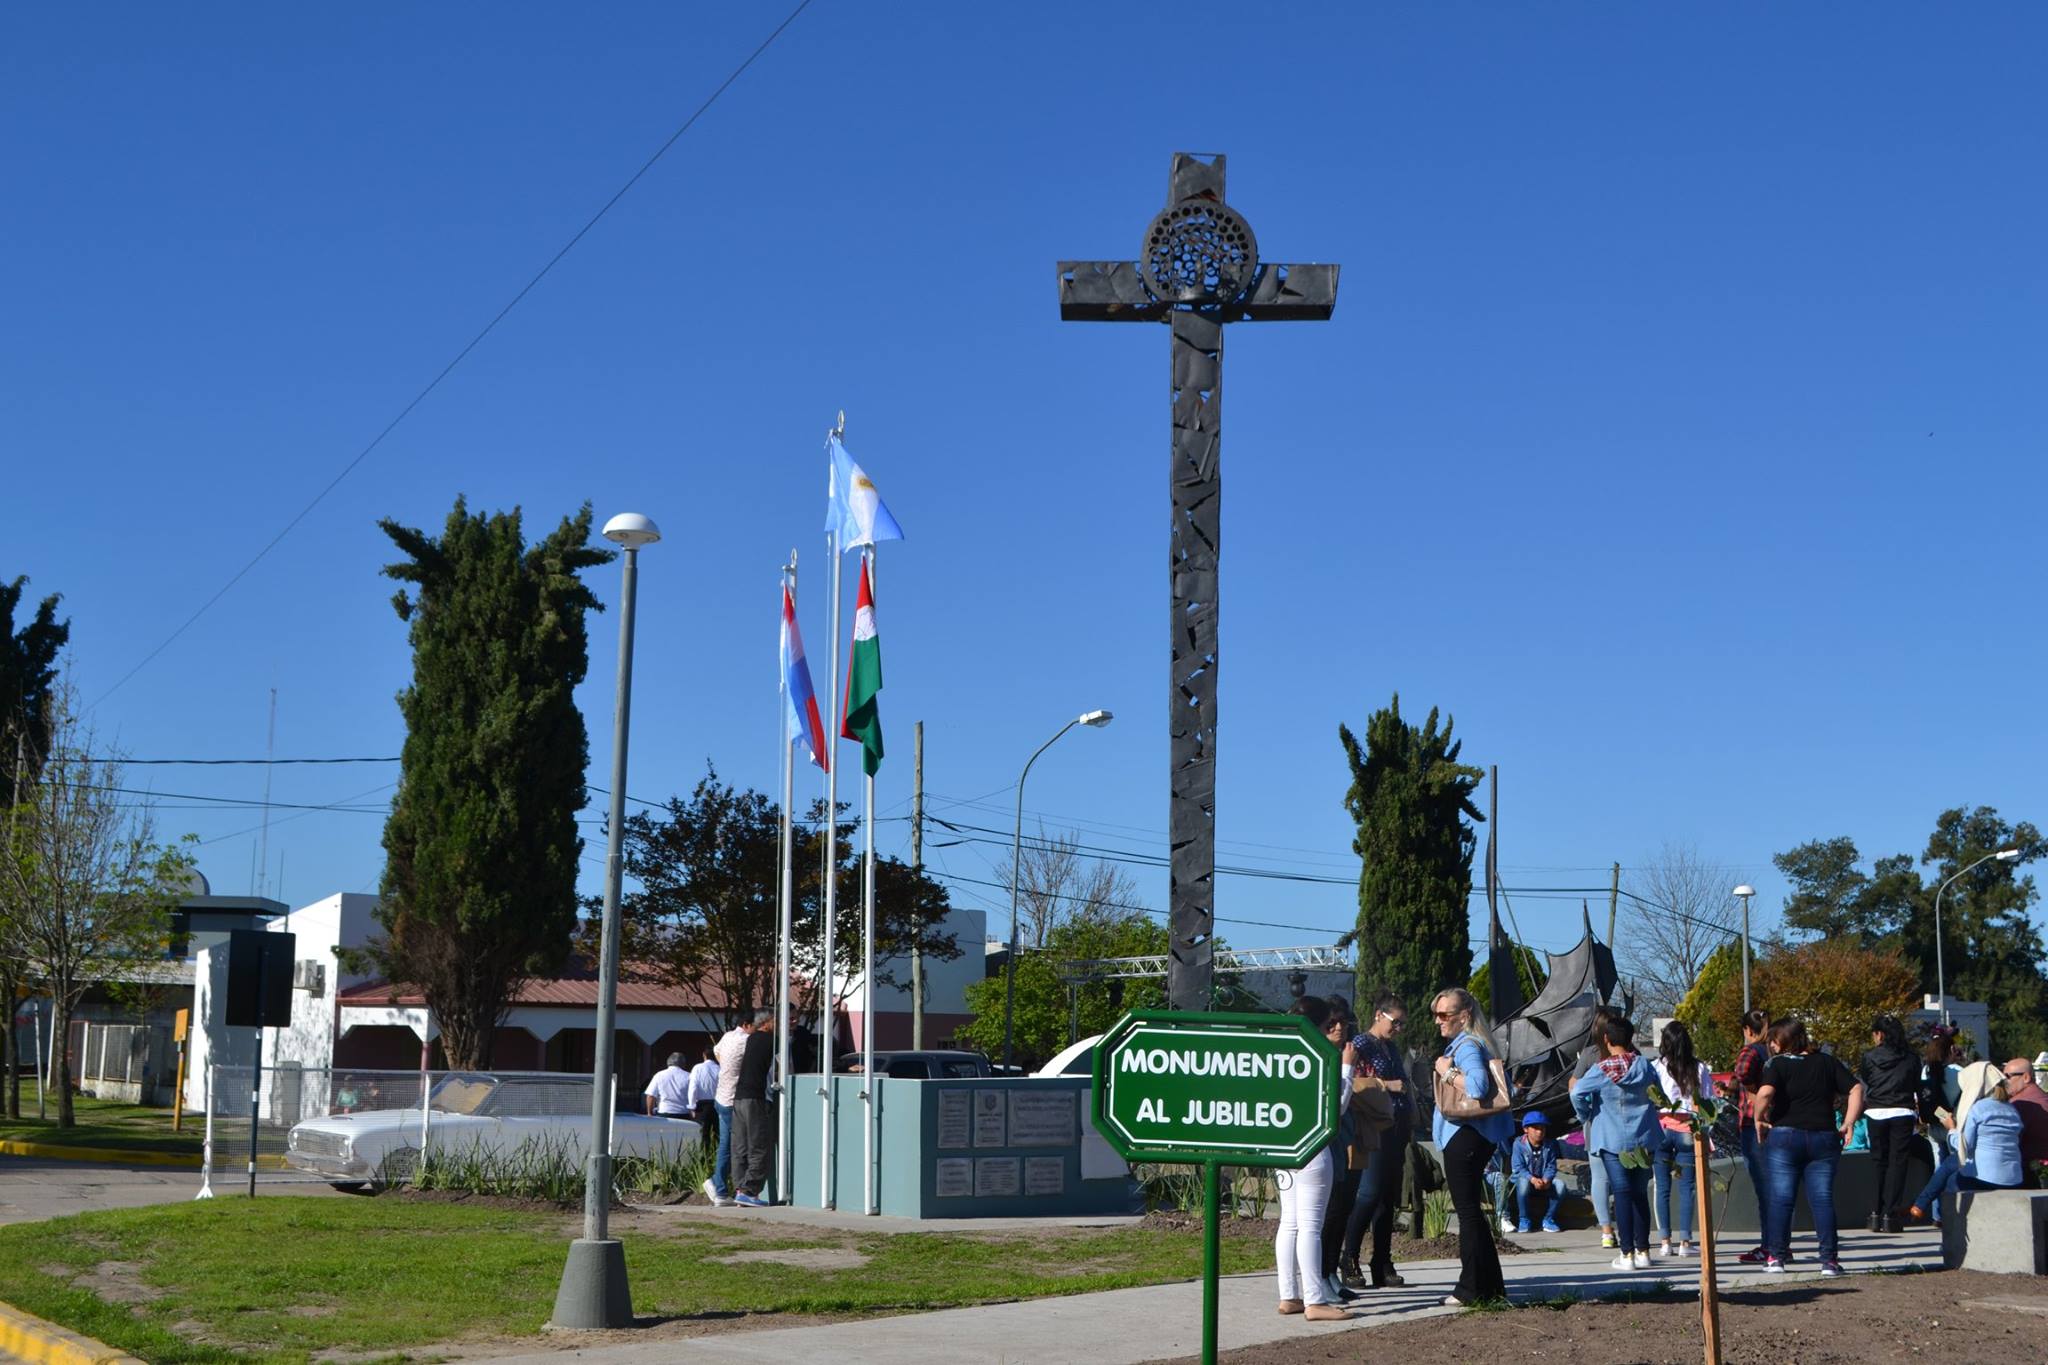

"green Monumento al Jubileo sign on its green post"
[1092, 1009, 1339, 1365]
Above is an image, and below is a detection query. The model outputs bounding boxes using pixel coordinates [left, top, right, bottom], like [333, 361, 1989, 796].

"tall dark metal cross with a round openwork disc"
[1059, 151, 1337, 1009]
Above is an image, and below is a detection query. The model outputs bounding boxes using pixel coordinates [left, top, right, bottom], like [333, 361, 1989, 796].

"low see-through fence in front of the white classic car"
[199, 1064, 616, 1199]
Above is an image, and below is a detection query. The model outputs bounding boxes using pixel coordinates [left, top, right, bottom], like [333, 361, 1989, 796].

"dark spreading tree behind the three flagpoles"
[584, 769, 961, 1023]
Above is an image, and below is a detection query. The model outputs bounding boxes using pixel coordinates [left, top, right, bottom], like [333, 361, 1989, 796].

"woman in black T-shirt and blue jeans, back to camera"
[1757, 1019, 1864, 1277]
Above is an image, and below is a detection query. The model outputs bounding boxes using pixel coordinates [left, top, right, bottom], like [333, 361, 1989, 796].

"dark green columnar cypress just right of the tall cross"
[1337, 694, 1485, 1007]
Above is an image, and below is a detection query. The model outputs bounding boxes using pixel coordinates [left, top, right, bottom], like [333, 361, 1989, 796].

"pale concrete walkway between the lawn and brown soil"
[498, 1220, 1942, 1365]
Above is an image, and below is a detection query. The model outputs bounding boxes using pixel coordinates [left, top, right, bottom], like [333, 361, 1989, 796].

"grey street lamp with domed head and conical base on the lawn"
[553, 512, 662, 1330]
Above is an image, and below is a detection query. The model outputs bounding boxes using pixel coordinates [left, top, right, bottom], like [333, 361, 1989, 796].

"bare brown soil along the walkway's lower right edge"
[1155, 1271, 2048, 1365]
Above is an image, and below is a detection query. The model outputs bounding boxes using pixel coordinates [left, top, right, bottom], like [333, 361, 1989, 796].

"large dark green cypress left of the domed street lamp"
[356, 497, 612, 1066]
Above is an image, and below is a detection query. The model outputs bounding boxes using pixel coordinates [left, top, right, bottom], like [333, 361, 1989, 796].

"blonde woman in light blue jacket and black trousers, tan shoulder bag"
[1430, 986, 1516, 1308]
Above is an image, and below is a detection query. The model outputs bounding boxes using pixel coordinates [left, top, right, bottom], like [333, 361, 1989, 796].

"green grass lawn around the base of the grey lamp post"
[0, 1195, 1272, 1363]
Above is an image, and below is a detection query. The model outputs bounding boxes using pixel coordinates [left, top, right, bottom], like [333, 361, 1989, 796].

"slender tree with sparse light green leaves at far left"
[0, 688, 193, 1128]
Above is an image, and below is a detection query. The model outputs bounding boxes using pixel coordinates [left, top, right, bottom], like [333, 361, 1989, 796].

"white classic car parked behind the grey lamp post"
[285, 1072, 700, 1185]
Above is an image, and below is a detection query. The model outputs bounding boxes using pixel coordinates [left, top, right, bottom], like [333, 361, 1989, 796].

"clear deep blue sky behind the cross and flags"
[0, 0, 2048, 970]
